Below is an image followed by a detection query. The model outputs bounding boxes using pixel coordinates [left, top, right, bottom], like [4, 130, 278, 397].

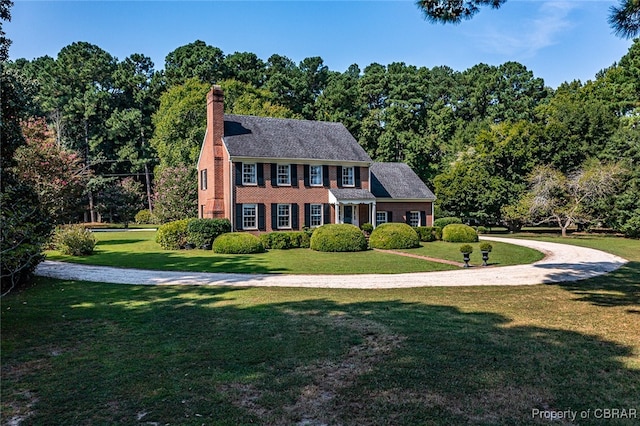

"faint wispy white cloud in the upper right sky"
[475, 1, 579, 58]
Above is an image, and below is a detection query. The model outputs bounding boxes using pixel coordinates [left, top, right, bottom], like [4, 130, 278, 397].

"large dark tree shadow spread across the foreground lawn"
[2, 279, 640, 425]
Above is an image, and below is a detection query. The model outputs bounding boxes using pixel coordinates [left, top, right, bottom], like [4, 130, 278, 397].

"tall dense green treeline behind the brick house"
[5, 40, 640, 233]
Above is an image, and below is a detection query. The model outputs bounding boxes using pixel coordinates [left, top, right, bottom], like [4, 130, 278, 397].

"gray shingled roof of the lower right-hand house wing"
[371, 163, 436, 200]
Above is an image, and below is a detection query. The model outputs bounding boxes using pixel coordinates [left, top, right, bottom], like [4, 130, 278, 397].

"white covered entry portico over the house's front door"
[329, 188, 376, 226]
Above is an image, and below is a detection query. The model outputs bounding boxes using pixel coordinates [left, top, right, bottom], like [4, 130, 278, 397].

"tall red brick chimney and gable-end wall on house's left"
[198, 85, 225, 218]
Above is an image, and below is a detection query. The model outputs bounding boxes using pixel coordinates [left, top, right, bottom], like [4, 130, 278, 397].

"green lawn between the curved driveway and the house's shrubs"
[47, 231, 542, 274]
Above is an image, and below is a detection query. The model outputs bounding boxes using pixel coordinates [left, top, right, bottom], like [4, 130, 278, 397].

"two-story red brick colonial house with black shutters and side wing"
[198, 86, 435, 233]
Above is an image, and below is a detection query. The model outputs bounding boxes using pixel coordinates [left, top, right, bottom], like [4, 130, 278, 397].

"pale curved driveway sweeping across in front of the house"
[36, 237, 627, 289]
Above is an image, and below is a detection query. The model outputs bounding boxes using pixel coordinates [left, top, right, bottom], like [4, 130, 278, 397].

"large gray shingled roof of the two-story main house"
[224, 114, 371, 162]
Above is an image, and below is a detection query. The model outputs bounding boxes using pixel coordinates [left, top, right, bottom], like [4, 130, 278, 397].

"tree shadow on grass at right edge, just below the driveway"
[544, 262, 640, 312]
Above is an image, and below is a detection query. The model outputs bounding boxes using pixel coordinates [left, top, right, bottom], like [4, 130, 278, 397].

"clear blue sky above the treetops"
[4, 0, 631, 87]
